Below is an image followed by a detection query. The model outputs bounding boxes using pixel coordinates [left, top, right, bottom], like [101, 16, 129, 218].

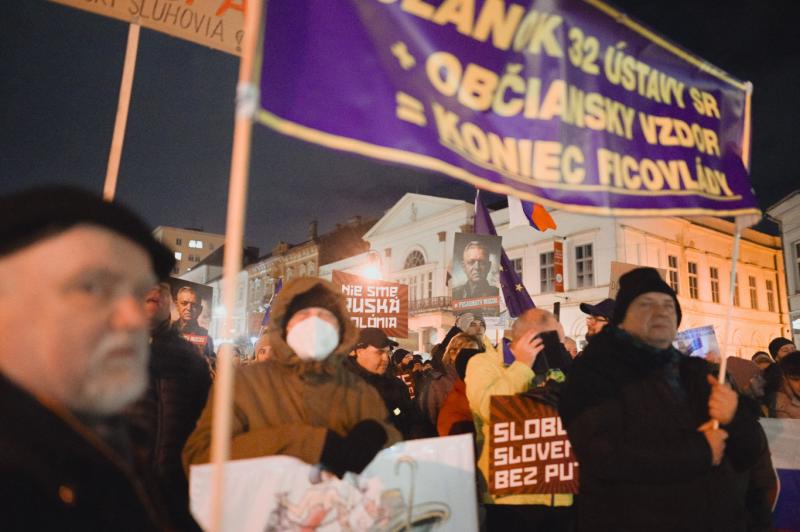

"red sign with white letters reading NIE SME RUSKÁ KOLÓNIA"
[331, 271, 408, 338]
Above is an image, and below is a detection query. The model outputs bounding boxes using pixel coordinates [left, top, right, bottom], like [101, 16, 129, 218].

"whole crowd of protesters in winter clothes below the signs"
[0, 188, 800, 532]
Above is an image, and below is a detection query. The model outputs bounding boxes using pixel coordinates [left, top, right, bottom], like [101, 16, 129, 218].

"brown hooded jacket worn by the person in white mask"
[183, 277, 400, 469]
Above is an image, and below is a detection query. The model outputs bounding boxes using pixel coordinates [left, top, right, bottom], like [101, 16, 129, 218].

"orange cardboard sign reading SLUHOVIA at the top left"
[51, 0, 247, 55]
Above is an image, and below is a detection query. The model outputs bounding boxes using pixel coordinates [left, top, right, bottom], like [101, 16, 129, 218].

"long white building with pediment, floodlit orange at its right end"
[320, 194, 789, 358]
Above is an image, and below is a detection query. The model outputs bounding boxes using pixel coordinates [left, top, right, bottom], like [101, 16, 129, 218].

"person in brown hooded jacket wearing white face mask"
[183, 277, 400, 476]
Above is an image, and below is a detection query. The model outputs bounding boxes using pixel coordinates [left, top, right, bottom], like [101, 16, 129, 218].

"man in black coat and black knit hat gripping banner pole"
[559, 268, 766, 532]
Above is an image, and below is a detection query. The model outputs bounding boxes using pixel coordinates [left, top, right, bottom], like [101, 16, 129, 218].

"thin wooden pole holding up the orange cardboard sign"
[103, 23, 141, 201]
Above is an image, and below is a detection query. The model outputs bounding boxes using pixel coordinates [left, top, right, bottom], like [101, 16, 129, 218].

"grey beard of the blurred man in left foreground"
[71, 332, 150, 416]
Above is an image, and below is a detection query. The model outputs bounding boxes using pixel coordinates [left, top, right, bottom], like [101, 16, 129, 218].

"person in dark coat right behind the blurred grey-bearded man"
[125, 283, 211, 530]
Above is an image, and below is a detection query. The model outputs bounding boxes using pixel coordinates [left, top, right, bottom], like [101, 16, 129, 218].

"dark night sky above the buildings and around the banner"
[0, 0, 800, 254]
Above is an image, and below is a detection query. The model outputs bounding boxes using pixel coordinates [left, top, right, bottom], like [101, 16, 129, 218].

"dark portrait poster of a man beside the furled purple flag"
[450, 233, 502, 316]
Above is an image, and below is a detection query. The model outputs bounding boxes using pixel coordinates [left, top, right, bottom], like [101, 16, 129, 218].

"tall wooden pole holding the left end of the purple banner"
[210, 0, 263, 532]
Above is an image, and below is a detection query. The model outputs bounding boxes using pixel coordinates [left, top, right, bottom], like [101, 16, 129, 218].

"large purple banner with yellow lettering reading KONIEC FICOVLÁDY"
[259, 0, 759, 215]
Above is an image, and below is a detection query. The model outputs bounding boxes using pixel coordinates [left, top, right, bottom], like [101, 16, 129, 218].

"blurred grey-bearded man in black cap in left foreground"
[0, 186, 174, 530]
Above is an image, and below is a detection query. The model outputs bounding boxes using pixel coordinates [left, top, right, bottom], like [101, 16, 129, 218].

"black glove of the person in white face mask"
[320, 419, 388, 478]
